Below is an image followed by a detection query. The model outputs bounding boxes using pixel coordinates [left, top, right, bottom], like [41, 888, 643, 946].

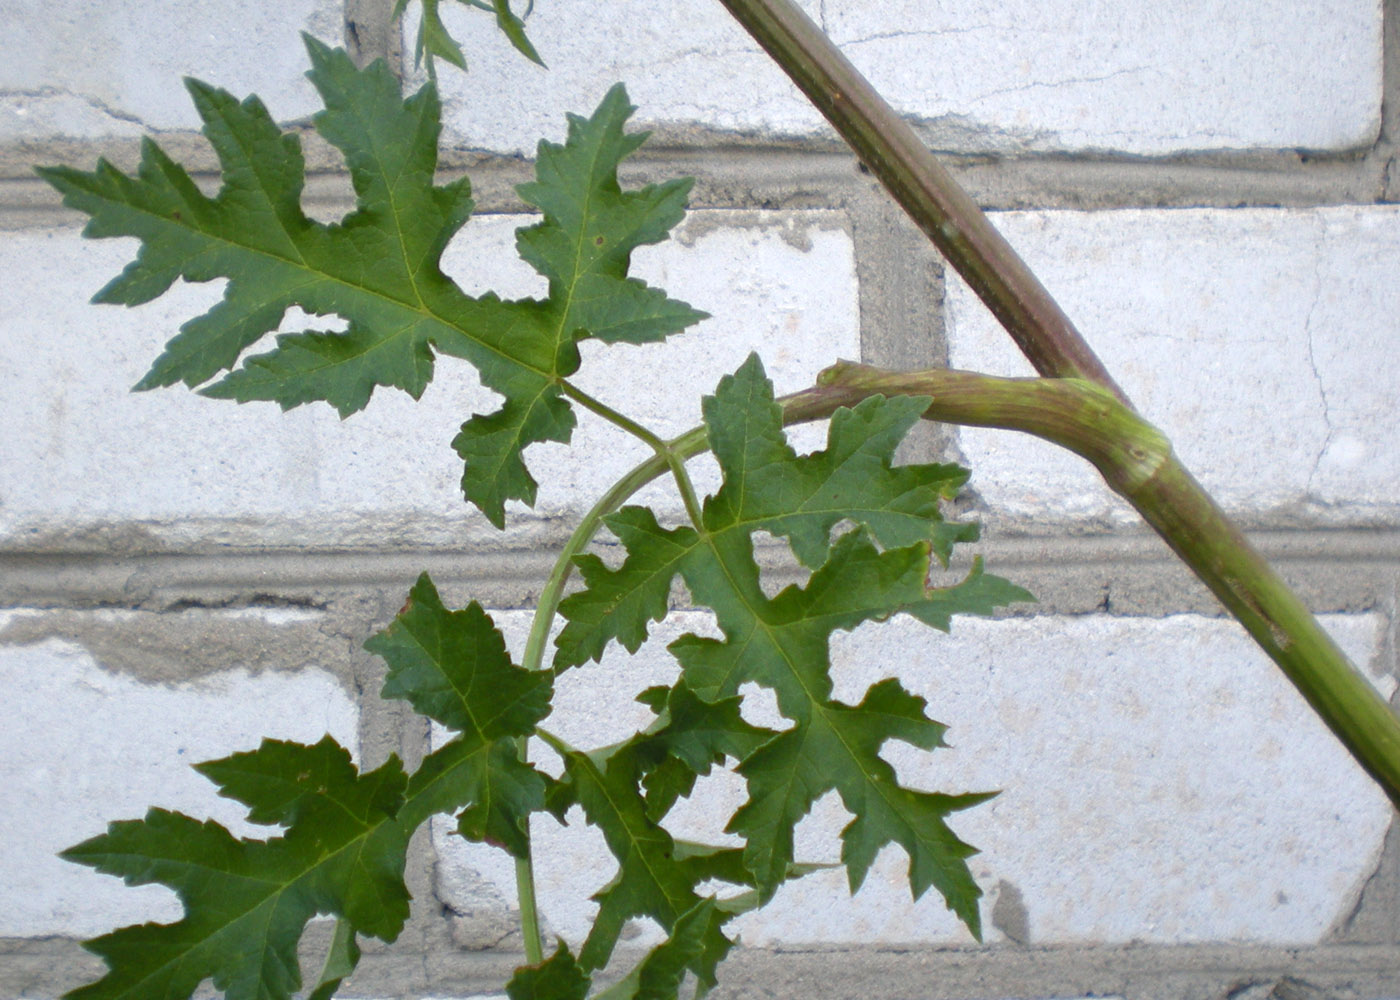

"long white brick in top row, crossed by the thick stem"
[417, 0, 1382, 154]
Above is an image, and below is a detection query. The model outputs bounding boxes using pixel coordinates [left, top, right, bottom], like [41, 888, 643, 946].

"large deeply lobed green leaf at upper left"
[39, 43, 704, 527]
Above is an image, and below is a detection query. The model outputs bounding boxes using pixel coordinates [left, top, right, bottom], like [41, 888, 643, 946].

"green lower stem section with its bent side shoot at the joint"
[783, 363, 1400, 807]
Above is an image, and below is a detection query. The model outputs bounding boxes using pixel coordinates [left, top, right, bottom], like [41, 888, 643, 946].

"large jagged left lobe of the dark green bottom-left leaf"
[63, 737, 410, 1000]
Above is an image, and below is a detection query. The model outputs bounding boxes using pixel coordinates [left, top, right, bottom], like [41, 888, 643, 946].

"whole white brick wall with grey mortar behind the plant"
[0, 0, 1400, 1000]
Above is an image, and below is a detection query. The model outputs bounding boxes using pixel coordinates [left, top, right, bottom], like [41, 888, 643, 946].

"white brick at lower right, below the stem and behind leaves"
[434, 612, 1394, 945]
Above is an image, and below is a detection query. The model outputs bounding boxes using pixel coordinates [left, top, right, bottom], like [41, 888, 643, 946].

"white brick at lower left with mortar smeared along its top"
[0, 612, 358, 937]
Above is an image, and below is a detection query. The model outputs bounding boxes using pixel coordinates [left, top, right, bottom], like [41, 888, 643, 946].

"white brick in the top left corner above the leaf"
[0, 0, 343, 141]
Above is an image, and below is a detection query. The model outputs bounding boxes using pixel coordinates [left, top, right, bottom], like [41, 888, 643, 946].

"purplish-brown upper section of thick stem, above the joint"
[720, 0, 1127, 403]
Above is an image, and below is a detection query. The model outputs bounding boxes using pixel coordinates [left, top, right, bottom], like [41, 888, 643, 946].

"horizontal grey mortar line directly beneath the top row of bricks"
[0, 144, 1389, 230]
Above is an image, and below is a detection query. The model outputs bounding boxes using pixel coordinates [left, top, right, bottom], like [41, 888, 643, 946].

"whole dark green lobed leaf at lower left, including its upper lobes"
[63, 574, 552, 1000]
